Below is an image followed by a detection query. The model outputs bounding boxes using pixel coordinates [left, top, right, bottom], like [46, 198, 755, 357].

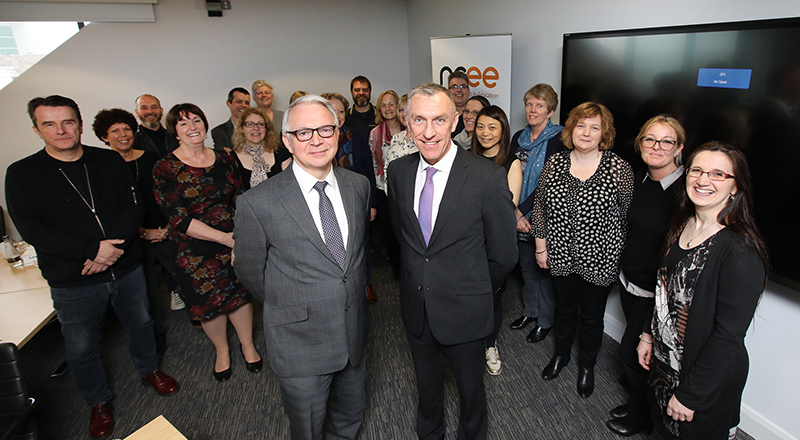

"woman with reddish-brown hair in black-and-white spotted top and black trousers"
[533, 102, 633, 397]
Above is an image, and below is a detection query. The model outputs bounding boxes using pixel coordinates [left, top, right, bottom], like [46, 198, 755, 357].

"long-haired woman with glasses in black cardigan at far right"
[637, 141, 769, 440]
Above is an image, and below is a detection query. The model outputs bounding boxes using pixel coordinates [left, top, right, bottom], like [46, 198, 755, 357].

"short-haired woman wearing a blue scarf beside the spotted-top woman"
[509, 84, 564, 343]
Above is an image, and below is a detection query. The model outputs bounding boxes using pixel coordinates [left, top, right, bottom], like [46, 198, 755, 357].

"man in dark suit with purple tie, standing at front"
[389, 84, 517, 439]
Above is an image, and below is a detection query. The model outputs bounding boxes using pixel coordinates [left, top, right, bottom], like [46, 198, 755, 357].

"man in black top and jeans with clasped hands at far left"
[6, 95, 178, 437]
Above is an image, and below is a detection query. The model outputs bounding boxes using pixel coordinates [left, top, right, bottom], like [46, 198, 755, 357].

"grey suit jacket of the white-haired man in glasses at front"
[233, 166, 369, 377]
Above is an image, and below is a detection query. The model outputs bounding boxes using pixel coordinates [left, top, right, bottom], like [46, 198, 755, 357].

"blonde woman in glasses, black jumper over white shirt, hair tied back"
[606, 115, 686, 436]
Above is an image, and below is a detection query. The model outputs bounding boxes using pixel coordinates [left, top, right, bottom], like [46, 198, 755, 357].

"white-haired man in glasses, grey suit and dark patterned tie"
[233, 95, 369, 439]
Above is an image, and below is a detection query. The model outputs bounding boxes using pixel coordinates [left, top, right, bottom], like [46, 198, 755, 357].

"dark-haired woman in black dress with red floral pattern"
[153, 104, 263, 382]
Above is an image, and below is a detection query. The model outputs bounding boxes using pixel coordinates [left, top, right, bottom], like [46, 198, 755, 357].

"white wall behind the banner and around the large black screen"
[408, 0, 800, 440]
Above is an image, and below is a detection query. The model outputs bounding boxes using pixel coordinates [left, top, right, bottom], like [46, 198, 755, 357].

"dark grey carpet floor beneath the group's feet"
[14, 257, 752, 440]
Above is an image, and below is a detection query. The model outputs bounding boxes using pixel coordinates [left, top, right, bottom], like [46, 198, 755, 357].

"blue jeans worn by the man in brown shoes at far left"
[50, 266, 158, 406]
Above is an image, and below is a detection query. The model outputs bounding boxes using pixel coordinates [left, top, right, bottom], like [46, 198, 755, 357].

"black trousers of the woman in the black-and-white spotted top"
[553, 274, 614, 367]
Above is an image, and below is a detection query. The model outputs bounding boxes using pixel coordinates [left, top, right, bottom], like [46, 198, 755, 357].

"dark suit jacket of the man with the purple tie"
[389, 144, 517, 345]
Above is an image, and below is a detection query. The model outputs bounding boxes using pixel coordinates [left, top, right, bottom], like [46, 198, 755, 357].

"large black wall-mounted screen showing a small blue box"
[560, 18, 800, 287]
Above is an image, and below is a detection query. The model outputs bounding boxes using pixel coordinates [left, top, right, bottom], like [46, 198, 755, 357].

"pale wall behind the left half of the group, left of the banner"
[0, 0, 410, 237]
